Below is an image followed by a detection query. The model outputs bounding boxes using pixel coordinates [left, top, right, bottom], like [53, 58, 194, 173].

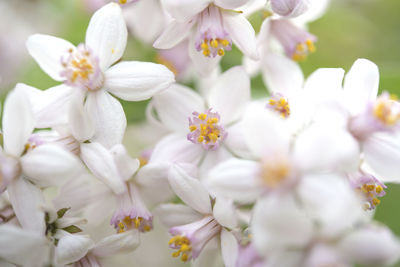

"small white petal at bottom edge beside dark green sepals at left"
[55, 234, 94, 264]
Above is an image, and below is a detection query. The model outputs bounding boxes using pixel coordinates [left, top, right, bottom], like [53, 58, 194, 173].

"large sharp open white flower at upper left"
[27, 3, 174, 147]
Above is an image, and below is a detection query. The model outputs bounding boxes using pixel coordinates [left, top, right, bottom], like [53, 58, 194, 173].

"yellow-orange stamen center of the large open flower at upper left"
[61, 44, 104, 91]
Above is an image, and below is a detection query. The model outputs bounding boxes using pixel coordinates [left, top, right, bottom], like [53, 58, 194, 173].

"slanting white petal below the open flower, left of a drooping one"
[81, 143, 126, 194]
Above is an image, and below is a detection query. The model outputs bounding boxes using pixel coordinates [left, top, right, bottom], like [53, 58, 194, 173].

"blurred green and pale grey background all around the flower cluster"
[0, 0, 400, 266]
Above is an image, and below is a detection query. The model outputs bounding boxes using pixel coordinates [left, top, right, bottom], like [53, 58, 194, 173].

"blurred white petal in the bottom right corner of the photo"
[339, 225, 400, 266]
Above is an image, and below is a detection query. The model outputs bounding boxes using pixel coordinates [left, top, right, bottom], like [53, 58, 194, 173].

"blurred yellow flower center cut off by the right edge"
[373, 94, 400, 126]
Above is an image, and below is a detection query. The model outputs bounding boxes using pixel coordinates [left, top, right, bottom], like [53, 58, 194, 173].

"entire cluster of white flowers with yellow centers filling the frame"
[0, 0, 400, 267]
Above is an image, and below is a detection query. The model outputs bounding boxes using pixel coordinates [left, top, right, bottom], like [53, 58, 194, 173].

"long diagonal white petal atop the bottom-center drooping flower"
[168, 165, 212, 214]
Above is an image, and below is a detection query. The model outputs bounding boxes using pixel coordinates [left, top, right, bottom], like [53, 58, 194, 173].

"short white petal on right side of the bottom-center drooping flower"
[213, 196, 238, 229]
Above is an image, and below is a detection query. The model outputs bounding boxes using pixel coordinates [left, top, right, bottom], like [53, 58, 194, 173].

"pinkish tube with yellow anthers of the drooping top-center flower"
[195, 5, 232, 57]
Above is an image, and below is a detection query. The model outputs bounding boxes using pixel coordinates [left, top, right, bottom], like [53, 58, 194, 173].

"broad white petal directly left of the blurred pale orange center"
[204, 159, 262, 203]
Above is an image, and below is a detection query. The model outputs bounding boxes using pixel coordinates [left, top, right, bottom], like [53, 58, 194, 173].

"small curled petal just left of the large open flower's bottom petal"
[68, 92, 94, 142]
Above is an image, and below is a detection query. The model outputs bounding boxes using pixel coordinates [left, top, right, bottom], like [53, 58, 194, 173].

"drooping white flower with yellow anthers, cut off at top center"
[154, 0, 258, 74]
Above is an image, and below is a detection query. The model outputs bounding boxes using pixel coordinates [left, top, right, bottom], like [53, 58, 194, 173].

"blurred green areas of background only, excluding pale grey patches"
[0, 0, 400, 266]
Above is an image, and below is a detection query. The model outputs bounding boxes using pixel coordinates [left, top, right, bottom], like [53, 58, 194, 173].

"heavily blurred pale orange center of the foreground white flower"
[261, 160, 291, 188]
